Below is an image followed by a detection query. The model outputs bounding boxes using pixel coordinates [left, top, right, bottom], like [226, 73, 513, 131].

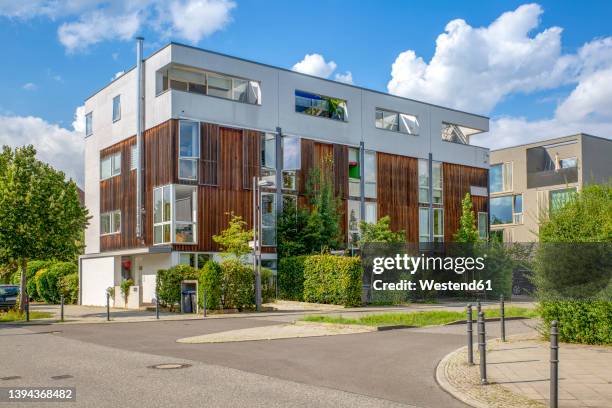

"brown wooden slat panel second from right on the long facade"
[376, 153, 419, 242]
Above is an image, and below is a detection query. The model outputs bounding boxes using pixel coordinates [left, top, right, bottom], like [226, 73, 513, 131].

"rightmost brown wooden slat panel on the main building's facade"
[443, 163, 489, 242]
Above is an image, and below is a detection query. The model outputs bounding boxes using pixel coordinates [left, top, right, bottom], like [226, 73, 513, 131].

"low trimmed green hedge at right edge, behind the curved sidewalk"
[539, 300, 612, 344]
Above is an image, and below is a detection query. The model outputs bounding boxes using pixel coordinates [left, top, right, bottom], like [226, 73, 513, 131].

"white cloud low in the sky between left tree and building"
[0, 115, 83, 186]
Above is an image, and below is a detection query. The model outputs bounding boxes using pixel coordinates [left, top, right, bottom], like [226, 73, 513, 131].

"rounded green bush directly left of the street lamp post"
[221, 258, 255, 311]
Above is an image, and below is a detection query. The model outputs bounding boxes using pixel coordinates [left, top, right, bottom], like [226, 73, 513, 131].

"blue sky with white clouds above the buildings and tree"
[0, 0, 612, 186]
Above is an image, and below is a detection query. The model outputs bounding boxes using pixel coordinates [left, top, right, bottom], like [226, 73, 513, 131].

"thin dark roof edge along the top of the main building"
[85, 41, 489, 119]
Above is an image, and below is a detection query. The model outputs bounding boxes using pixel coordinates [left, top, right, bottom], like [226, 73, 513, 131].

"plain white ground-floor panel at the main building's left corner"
[81, 256, 115, 306]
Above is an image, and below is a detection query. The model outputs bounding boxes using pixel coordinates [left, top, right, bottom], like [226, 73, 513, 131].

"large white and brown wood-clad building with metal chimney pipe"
[80, 43, 489, 307]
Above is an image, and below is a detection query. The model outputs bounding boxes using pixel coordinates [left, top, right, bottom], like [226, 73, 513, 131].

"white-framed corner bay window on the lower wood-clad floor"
[153, 184, 198, 244]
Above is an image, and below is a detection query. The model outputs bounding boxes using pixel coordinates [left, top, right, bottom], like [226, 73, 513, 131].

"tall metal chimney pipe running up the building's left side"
[136, 37, 144, 238]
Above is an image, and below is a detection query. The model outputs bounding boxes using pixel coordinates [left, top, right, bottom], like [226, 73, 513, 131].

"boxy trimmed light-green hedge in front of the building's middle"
[304, 255, 362, 306]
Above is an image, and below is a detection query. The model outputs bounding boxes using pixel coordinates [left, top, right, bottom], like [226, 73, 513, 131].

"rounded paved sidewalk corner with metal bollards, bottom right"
[437, 335, 612, 408]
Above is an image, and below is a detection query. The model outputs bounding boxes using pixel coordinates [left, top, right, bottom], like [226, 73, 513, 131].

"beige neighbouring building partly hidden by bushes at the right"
[489, 133, 612, 242]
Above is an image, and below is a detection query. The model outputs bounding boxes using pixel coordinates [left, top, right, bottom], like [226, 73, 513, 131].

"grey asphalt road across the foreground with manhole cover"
[0, 318, 529, 408]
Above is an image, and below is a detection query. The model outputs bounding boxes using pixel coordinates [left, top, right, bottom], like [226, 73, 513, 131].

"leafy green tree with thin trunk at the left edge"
[0, 146, 89, 311]
